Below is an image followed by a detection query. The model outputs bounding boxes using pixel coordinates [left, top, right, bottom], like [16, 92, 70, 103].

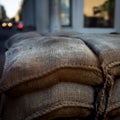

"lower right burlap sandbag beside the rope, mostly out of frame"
[107, 79, 120, 117]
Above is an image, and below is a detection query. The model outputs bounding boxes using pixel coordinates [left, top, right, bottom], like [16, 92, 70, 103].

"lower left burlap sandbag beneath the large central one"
[3, 82, 94, 120]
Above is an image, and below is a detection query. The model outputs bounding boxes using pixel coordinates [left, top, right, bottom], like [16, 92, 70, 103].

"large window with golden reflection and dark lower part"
[84, 0, 115, 28]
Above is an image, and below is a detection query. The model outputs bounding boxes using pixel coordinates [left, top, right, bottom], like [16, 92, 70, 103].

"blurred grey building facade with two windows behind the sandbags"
[22, 0, 120, 33]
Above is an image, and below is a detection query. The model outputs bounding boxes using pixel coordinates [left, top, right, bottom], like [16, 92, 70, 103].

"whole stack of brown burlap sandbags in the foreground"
[0, 32, 120, 120]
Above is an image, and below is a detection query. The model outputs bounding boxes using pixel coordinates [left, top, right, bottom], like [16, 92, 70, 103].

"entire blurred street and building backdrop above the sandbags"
[0, 0, 120, 41]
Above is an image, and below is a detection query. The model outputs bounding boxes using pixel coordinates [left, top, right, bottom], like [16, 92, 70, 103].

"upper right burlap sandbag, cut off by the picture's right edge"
[72, 34, 120, 76]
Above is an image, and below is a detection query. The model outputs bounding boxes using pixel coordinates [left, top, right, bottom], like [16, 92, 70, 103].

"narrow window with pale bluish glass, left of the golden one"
[60, 0, 71, 26]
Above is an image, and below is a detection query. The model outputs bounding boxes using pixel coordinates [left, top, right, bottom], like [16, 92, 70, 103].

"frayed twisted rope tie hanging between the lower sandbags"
[95, 74, 114, 120]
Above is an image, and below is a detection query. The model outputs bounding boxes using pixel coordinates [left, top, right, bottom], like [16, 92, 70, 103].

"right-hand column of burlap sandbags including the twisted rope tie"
[69, 34, 120, 118]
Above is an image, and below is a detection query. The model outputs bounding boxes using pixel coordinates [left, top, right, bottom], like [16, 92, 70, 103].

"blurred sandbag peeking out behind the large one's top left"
[5, 31, 41, 49]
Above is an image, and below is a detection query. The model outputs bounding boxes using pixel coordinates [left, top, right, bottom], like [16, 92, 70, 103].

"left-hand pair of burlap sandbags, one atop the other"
[0, 32, 103, 120]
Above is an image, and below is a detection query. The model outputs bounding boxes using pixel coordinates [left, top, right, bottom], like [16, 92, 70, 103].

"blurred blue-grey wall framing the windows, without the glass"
[23, 0, 120, 33]
